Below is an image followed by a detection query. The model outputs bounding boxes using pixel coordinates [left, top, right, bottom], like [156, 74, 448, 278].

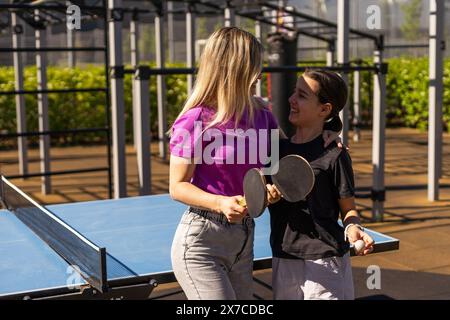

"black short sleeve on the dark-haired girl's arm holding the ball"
[333, 150, 355, 199]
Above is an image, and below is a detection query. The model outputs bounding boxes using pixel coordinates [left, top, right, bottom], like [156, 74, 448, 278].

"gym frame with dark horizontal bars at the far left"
[0, 0, 112, 197]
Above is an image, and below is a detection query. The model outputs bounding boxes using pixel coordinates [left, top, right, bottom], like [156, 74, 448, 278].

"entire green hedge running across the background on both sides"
[0, 58, 450, 147]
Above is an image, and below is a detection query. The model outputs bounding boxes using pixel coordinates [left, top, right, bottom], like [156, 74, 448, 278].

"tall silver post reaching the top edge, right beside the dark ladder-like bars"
[108, 0, 127, 199]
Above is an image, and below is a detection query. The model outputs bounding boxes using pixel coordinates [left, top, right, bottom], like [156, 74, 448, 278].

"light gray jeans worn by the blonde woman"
[171, 209, 255, 300]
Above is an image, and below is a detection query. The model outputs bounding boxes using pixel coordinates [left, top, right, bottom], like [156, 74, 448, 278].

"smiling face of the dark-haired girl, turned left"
[289, 76, 332, 127]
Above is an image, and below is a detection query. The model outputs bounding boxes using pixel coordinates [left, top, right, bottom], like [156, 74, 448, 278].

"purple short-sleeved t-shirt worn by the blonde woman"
[170, 106, 278, 196]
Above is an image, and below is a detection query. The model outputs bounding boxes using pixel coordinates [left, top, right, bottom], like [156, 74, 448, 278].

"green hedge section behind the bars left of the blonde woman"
[0, 64, 187, 147]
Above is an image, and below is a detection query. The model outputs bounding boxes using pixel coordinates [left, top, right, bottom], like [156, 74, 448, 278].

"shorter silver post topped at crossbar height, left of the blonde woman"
[133, 66, 151, 195]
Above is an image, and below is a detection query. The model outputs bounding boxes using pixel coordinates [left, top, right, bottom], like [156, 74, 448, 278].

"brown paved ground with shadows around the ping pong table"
[0, 129, 450, 299]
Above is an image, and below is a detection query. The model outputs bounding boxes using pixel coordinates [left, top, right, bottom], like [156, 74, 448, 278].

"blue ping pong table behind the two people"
[0, 195, 399, 299]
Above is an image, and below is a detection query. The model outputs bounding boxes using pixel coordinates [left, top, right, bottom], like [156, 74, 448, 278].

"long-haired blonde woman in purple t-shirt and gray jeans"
[169, 27, 335, 300]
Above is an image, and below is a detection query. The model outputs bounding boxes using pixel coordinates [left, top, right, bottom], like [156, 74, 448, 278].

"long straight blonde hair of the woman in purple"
[171, 27, 263, 132]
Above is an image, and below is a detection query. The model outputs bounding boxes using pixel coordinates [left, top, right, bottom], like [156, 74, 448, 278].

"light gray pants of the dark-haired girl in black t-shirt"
[272, 253, 355, 300]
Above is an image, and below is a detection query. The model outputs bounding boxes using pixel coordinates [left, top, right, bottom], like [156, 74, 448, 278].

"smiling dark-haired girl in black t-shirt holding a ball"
[269, 70, 374, 300]
